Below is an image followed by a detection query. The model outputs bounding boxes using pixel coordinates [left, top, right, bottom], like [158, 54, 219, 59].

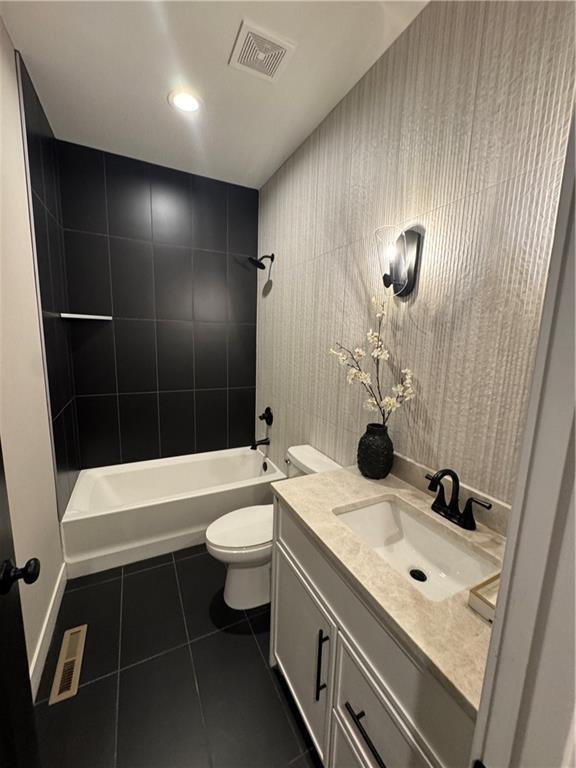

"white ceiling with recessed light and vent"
[0, 1, 426, 187]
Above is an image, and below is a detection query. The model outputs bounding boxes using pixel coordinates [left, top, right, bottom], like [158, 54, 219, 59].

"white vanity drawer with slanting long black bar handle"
[334, 635, 435, 768]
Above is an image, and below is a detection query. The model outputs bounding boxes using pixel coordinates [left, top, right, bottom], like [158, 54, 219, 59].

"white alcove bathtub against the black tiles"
[61, 448, 285, 578]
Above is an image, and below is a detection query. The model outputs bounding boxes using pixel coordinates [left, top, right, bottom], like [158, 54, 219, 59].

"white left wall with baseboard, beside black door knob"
[0, 20, 64, 688]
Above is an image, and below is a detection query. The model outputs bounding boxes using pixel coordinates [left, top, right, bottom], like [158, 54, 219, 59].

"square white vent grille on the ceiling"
[228, 21, 296, 81]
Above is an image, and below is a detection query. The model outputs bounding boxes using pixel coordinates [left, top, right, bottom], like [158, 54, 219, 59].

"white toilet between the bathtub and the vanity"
[206, 445, 340, 610]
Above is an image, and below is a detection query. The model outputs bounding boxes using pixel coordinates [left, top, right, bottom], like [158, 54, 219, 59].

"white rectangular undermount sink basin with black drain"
[334, 495, 498, 601]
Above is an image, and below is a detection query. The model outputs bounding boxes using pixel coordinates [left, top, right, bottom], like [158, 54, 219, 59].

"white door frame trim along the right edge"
[473, 118, 576, 768]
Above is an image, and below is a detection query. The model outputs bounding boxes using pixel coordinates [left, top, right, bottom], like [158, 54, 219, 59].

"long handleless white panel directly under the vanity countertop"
[275, 500, 474, 768]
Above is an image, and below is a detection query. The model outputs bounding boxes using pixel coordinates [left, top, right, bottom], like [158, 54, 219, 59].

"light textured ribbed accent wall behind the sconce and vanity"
[257, 2, 574, 502]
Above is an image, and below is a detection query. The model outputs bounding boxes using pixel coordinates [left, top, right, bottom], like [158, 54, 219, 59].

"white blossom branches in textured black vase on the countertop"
[330, 296, 415, 479]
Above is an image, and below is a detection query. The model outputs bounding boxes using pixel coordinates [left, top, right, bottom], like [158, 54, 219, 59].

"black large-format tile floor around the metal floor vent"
[36, 547, 321, 768]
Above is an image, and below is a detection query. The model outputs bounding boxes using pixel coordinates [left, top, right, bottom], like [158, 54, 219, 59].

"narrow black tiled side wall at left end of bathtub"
[19, 60, 80, 517]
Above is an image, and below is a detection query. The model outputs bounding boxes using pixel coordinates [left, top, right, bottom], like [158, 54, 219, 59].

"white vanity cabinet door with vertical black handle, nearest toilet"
[274, 545, 336, 757]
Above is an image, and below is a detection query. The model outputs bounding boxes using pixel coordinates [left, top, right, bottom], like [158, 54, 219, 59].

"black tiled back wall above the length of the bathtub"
[57, 141, 258, 467]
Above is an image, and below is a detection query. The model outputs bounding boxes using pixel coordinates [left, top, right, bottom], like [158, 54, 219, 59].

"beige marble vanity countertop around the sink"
[272, 467, 506, 717]
